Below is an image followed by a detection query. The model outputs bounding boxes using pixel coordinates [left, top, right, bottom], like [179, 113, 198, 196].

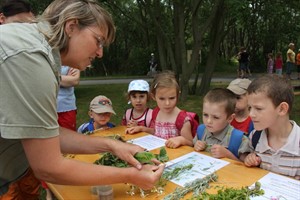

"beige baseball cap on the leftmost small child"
[90, 95, 116, 114]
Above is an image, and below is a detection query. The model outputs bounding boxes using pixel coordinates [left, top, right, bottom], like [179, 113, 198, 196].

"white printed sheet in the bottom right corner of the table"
[251, 172, 300, 200]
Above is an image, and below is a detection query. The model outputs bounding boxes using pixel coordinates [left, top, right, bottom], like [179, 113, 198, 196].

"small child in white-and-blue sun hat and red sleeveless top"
[122, 80, 152, 134]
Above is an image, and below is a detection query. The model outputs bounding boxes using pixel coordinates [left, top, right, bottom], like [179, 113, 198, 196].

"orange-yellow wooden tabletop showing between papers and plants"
[48, 126, 268, 200]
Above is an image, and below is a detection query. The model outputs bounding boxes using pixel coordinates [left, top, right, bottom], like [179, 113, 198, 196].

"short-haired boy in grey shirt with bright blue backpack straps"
[193, 88, 251, 161]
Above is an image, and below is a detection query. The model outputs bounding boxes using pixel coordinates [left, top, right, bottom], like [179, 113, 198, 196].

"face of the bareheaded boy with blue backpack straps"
[202, 102, 233, 134]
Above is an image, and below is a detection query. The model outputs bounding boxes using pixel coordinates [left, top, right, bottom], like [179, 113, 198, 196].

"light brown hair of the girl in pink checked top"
[150, 70, 180, 97]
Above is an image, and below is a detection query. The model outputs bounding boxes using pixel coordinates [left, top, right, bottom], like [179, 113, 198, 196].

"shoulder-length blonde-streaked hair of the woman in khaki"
[41, 0, 115, 52]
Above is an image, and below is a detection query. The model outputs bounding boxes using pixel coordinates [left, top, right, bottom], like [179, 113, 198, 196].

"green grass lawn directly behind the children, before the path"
[75, 83, 300, 127]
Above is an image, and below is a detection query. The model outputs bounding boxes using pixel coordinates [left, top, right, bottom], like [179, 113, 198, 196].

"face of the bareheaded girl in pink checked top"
[154, 88, 177, 113]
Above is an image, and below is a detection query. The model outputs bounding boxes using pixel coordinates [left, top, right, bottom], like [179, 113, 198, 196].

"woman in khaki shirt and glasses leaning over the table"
[0, 0, 164, 199]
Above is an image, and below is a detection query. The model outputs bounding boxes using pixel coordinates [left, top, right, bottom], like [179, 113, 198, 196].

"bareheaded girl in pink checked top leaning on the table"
[146, 71, 193, 148]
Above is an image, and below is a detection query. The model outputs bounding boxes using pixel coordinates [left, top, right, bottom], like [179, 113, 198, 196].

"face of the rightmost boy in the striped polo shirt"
[248, 92, 279, 130]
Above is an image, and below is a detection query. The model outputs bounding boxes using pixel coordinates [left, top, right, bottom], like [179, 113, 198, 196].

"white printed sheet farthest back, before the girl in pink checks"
[128, 135, 166, 151]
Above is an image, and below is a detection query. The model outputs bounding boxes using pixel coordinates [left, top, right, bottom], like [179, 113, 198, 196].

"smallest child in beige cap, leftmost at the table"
[77, 95, 116, 133]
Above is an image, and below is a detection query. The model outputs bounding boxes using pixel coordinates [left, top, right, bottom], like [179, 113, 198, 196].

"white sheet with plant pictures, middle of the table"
[165, 152, 229, 187]
